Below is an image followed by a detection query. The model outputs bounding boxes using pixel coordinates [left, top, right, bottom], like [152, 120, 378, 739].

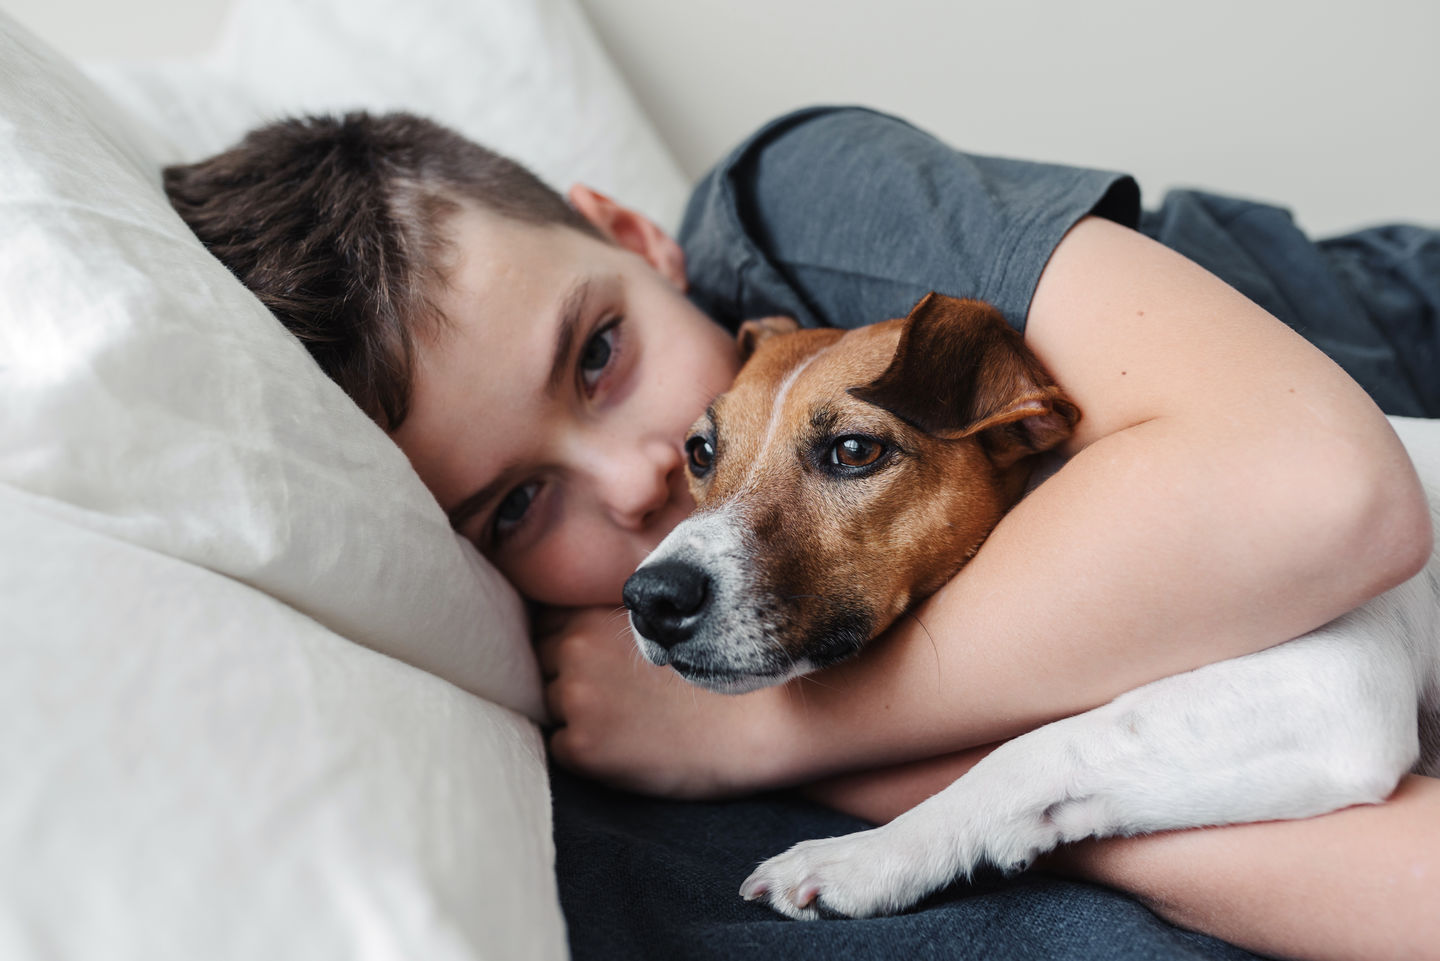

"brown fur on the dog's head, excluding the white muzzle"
[691, 294, 1080, 666]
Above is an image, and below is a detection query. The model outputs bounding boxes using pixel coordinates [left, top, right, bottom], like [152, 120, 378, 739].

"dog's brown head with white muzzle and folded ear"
[625, 294, 1080, 693]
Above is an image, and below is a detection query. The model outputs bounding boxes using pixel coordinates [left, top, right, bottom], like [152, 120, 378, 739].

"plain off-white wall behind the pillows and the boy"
[0, 0, 1440, 233]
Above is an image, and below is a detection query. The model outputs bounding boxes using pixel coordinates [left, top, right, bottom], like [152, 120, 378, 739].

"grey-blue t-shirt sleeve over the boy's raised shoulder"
[680, 108, 1139, 331]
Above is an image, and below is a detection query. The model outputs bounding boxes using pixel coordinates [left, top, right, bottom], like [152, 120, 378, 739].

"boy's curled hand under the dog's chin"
[536, 608, 785, 798]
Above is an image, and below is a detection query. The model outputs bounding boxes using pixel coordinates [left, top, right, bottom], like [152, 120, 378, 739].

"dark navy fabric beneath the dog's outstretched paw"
[552, 769, 1256, 961]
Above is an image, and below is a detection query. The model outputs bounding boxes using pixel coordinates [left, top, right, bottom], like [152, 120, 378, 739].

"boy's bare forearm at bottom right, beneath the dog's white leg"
[1050, 775, 1440, 961]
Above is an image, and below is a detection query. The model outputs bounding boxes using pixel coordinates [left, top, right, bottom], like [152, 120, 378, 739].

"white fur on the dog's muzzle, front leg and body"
[636, 419, 1440, 919]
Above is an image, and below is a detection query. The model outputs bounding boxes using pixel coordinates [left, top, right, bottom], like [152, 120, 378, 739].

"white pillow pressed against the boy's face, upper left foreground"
[0, 11, 541, 716]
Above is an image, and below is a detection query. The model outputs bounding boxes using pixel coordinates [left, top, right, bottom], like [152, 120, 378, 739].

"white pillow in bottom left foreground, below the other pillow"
[0, 484, 566, 961]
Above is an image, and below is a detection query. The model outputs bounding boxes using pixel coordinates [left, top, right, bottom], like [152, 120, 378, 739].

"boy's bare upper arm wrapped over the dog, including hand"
[543, 219, 1430, 795]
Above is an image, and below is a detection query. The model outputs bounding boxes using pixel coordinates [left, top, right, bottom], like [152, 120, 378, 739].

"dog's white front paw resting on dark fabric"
[740, 827, 955, 921]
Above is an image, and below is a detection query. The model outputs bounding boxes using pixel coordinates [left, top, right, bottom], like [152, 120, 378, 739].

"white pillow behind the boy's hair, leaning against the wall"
[88, 0, 688, 229]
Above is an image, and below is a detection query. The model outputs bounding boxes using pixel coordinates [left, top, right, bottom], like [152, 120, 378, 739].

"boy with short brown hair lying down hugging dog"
[166, 109, 1440, 954]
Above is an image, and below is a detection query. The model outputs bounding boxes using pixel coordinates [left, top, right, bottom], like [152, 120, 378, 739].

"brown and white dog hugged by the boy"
[624, 294, 1440, 919]
